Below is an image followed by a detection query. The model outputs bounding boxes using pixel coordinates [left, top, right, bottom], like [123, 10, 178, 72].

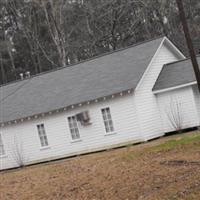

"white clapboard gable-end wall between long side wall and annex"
[135, 38, 182, 140]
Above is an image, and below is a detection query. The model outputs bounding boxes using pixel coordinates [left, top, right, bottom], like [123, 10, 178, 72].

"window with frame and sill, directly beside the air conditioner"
[67, 115, 81, 143]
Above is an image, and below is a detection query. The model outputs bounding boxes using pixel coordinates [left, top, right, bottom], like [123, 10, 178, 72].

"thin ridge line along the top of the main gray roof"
[0, 35, 166, 88]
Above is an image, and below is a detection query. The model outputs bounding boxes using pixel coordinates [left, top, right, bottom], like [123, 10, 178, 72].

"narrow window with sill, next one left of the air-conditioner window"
[37, 123, 49, 149]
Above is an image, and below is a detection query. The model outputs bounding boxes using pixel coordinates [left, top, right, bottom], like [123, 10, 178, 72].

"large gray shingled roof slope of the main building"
[0, 38, 163, 123]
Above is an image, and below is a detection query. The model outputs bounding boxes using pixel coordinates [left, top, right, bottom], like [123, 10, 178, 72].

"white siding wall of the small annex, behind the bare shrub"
[157, 86, 199, 132]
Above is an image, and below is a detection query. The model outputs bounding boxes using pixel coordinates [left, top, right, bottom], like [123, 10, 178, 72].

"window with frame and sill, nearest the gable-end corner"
[101, 107, 115, 135]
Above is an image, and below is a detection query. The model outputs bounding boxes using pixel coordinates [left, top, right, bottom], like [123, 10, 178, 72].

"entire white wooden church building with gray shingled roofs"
[0, 37, 200, 170]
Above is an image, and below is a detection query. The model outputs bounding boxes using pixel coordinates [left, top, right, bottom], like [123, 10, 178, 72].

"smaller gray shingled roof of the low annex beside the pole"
[153, 56, 200, 91]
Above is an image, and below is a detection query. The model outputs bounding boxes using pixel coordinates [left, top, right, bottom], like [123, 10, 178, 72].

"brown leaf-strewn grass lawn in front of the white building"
[0, 131, 200, 200]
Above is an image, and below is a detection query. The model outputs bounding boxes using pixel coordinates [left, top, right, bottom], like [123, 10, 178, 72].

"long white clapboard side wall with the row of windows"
[0, 94, 141, 169]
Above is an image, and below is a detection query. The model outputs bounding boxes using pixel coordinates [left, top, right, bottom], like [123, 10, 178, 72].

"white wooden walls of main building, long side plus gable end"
[0, 38, 194, 169]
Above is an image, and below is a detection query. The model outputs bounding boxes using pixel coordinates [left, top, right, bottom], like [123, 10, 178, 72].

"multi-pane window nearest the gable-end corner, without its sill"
[101, 108, 114, 133]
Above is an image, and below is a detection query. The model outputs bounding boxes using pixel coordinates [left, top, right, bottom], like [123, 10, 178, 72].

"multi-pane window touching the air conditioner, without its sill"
[68, 116, 80, 140]
